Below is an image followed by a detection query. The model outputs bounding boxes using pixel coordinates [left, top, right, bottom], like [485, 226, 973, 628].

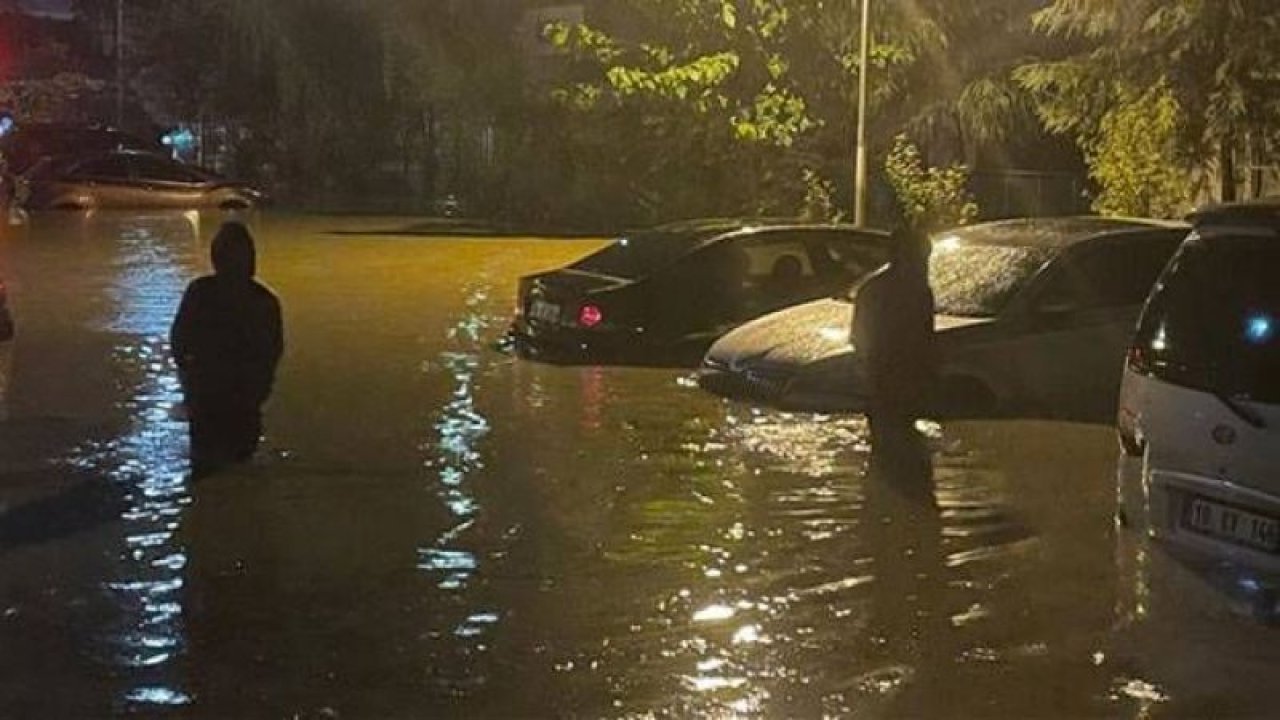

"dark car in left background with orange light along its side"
[24, 150, 264, 210]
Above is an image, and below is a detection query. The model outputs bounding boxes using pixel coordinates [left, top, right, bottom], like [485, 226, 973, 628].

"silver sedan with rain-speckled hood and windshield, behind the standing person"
[699, 217, 1188, 418]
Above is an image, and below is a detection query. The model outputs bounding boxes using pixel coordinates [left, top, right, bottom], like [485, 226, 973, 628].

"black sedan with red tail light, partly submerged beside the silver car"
[512, 220, 887, 364]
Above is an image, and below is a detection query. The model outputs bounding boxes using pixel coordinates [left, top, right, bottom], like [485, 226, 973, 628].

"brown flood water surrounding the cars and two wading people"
[0, 214, 1280, 719]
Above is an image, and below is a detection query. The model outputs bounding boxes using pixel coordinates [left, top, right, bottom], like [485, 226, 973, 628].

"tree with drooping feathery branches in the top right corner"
[1019, 0, 1280, 200]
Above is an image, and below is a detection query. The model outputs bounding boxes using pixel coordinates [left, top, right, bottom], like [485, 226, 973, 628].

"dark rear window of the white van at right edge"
[1135, 229, 1280, 402]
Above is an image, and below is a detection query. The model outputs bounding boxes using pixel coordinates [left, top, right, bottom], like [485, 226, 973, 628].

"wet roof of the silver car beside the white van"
[934, 215, 1190, 250]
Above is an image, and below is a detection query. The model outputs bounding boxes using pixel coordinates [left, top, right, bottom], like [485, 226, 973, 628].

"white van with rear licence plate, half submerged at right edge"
[1116, 200, 1280, 586]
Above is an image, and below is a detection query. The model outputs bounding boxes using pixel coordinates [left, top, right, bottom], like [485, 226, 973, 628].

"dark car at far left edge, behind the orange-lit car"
[0, 123, 164, 176]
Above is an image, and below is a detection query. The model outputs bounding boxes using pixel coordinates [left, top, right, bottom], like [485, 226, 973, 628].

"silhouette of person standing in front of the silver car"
[852, 229, 937, 447]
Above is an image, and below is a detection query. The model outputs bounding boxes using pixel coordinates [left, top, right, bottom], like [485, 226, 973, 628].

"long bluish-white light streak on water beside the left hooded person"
[73, 214, 200, 706]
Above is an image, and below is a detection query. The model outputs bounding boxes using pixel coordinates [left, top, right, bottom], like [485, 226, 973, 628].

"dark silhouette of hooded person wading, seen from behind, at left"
[170, 222, 284, 477]
